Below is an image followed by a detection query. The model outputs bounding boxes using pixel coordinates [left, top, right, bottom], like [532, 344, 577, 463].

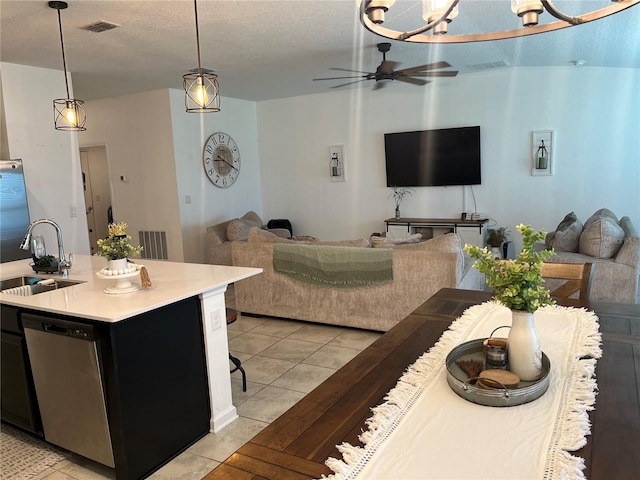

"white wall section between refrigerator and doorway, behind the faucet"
[0, 63, 89, 256]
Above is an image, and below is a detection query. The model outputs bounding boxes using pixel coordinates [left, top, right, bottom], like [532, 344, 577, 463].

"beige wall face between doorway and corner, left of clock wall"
[80, 90, 183, 262]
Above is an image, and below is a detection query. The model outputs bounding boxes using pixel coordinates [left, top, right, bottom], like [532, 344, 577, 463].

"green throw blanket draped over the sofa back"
[273, 243, 393, 287]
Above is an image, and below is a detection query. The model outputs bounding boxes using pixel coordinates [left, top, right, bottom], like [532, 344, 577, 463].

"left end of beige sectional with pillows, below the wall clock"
[207, 211, 291, 265]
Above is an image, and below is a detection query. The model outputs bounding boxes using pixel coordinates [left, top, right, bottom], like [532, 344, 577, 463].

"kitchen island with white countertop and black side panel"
[0, 255, 261, 479]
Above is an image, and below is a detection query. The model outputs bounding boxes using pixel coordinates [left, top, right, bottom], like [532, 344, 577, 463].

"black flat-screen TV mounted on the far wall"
[384, 126, 480, 187]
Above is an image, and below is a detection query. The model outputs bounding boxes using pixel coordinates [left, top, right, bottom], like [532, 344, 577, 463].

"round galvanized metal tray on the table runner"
[446, 338, 551, 407]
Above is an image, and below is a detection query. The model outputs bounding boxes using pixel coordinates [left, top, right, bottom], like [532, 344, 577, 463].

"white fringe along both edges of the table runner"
[322, 301, 602, 480]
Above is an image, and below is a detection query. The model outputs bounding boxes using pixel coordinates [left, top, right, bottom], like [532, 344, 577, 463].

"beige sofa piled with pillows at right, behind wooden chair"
[545, 208, 640, 303]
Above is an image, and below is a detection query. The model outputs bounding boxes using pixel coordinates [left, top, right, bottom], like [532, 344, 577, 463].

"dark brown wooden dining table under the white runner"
[205, 288, 640, 480]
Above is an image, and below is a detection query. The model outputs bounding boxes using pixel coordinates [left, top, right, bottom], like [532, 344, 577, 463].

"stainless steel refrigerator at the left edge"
[0, 160, 31, 262]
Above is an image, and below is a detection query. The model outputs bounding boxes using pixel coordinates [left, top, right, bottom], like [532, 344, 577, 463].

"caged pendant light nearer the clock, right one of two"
[182, 0, 220, 113]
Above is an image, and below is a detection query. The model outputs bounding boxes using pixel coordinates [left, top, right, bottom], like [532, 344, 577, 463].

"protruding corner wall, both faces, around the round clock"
[80, 89, 262, 263]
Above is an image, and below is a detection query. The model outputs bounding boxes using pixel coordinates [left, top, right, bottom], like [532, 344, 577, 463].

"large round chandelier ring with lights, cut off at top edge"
[360, 0, 640, 43]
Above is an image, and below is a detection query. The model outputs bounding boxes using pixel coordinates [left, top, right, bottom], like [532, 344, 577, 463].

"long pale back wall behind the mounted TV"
[258, 67, 640, 251]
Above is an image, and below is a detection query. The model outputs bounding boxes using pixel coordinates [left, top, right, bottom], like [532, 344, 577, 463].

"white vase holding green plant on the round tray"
[507, 310, 542, 382]
